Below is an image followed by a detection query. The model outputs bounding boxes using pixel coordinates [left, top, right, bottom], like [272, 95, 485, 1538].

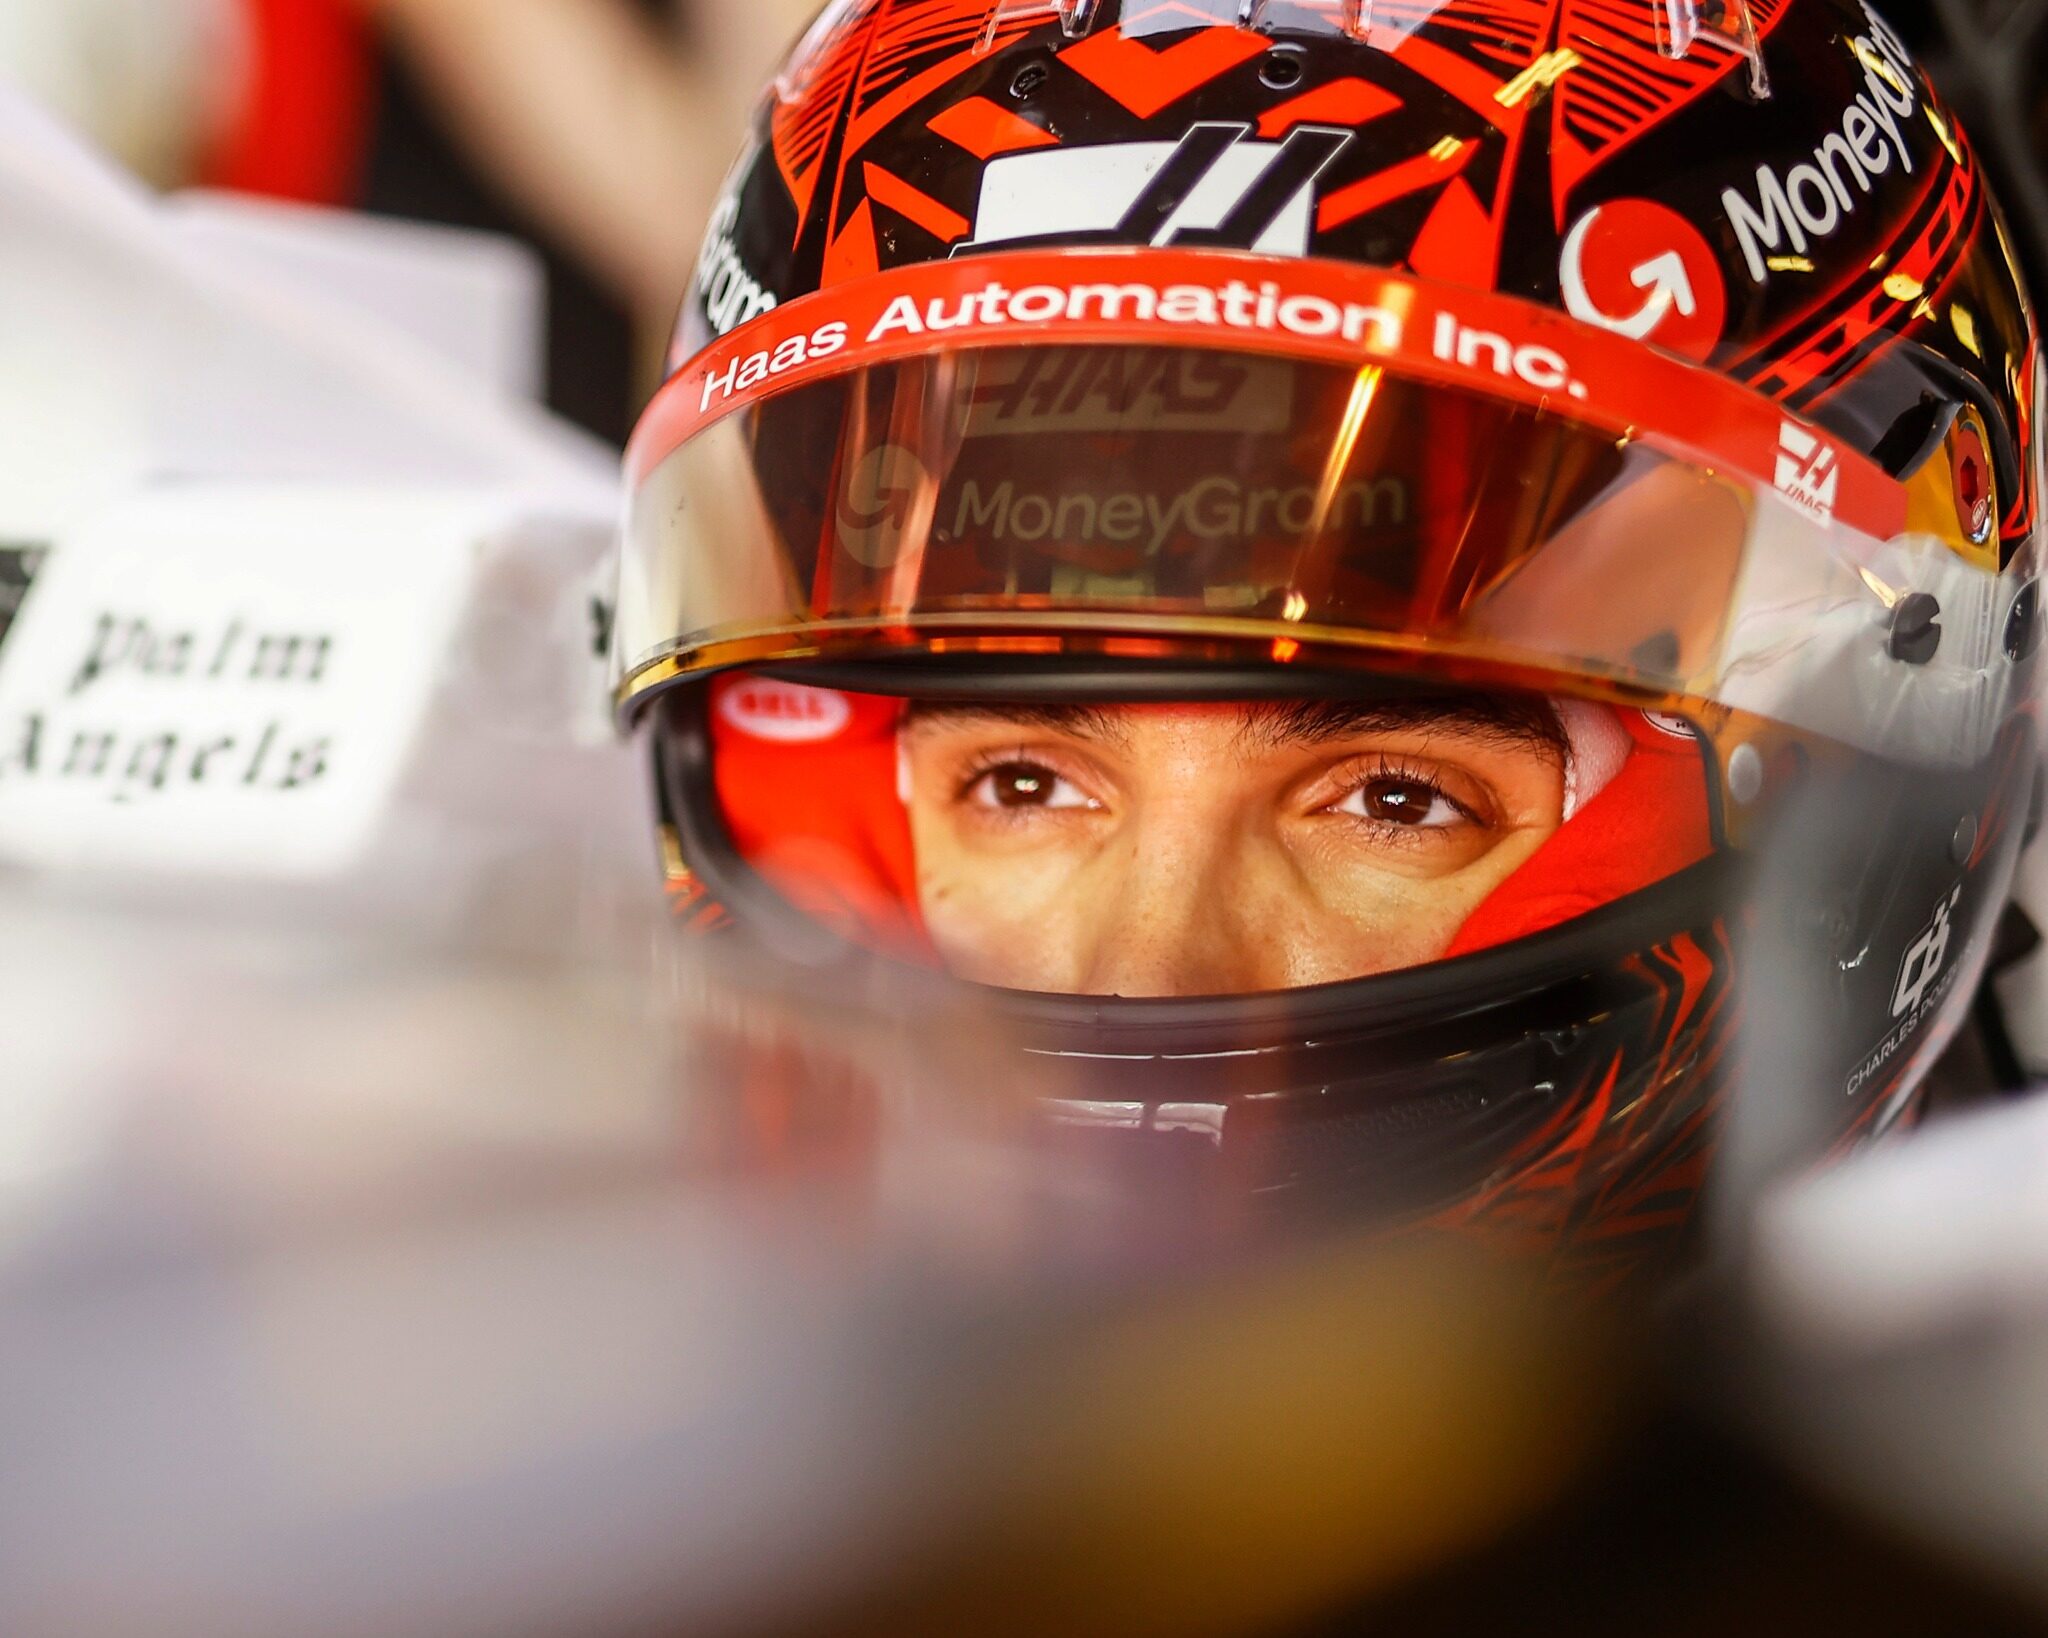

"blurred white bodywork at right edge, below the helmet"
[1745, 1091, 2048, 1599]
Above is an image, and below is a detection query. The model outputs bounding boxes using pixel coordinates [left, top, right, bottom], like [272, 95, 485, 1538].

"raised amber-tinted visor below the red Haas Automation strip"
[616, 346, 2003, 762]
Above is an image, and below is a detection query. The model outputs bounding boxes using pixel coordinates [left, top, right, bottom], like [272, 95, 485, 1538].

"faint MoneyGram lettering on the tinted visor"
[948, 473, 1409, 557]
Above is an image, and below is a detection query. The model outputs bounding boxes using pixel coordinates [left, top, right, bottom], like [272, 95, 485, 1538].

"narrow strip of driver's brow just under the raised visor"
[905, 692, 1565, 762]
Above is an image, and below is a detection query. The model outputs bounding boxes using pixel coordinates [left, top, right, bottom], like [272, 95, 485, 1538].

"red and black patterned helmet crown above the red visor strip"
[676, 0, 2036, 553]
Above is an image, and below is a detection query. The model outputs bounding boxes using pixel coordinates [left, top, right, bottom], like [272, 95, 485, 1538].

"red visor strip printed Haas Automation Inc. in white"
[627, 248, 1907, 541]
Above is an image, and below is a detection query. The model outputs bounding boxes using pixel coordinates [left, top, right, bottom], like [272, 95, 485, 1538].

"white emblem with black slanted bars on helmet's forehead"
[956, 123, 1352, 256]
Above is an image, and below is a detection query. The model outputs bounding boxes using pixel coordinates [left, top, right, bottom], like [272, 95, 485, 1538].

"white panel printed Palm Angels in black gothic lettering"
[0, 483, 516, 876]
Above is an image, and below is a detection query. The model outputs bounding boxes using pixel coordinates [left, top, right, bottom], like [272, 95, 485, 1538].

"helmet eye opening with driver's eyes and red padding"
[709, 676, 1712, 995]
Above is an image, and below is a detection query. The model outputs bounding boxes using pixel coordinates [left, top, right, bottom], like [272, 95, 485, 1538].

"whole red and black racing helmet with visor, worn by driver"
[614, 0, 2042, 1269]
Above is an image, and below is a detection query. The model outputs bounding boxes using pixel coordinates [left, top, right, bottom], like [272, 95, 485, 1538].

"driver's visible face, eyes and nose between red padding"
[899, 698, 1565, 995]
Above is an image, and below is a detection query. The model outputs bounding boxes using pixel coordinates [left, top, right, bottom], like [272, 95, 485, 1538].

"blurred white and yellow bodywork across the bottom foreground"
[0, 903, 2040, 1638]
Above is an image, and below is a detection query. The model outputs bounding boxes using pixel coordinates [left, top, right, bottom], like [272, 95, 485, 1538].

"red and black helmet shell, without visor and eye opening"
[647, 0, 2040, 1282]
